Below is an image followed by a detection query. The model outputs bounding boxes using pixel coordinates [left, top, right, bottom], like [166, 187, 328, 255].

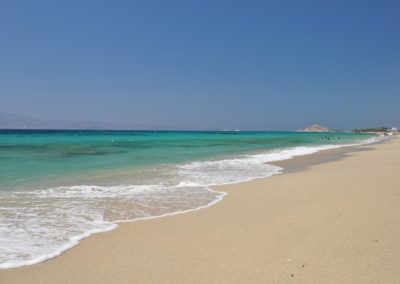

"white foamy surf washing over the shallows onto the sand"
[0, 137, 381, 269]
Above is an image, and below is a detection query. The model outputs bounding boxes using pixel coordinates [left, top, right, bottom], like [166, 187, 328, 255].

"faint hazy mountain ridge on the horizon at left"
[0, 112, 171, 130]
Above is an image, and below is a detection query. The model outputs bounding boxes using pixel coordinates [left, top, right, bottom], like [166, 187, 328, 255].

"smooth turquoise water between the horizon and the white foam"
[0, 131, 376, 190]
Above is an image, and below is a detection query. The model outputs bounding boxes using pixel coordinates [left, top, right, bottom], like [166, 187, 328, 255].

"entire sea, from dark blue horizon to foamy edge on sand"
[0, 130, 381, 269]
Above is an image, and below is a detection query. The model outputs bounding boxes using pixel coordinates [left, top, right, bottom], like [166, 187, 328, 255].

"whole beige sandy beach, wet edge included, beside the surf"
[0, 137, 400, 284]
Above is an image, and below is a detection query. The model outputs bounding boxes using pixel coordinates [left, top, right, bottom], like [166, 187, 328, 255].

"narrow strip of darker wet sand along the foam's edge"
[0, 137, 398, 283]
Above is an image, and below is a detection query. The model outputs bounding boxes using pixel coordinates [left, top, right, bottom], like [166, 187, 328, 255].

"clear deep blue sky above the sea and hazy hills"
[0, 0, 400, 130]
